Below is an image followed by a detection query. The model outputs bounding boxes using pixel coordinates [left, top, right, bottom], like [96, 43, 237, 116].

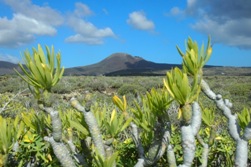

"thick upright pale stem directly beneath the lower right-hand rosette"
[180, 102, 201, 167]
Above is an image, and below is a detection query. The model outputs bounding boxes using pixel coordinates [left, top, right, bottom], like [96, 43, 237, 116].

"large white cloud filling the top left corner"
[0, 0, 63, 47]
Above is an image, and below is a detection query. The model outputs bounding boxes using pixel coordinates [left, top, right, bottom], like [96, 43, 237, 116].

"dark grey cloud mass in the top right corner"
[171, 0, 251, 49]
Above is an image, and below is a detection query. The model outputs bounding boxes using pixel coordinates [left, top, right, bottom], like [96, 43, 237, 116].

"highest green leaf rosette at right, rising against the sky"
[177, 37, 212, 76]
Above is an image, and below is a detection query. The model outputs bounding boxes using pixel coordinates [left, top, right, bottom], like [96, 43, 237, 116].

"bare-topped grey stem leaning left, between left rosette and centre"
[71, 98, 106, 158]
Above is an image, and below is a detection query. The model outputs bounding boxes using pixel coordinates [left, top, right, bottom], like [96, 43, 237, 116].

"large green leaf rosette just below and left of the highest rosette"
[164, 67, 200, 123]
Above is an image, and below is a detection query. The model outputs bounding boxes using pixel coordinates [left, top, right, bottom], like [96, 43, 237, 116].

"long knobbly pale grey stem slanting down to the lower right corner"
[201, 80, 251, 167]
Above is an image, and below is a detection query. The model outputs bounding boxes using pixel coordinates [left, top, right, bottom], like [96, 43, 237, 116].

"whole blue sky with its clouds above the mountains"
[0, 0, 251, 68]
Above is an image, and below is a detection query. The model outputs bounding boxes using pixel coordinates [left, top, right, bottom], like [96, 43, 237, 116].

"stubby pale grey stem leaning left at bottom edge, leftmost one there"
[44, 137, 76, 167]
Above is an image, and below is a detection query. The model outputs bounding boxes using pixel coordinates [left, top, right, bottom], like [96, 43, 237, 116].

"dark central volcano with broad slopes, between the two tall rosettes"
[65, 53, 179, 75]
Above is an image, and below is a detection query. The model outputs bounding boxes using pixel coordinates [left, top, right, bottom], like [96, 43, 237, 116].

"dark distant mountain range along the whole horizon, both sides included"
[0, 53, 251, 76]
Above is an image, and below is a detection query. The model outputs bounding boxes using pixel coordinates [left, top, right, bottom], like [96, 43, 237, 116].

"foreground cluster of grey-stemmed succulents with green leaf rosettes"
[0, 37, 251, 167]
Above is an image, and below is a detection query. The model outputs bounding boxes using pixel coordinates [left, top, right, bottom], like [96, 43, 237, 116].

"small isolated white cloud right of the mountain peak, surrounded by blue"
[127, 11, 155, 30]
